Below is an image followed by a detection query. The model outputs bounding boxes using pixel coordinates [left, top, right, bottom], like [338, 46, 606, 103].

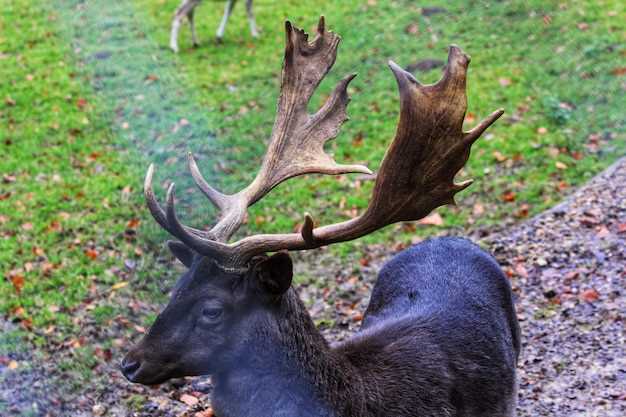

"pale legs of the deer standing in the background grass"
[170, 0, 259, 52]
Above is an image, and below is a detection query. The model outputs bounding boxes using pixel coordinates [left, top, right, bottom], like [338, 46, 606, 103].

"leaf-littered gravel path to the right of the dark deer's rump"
[486, 158, 626, 417]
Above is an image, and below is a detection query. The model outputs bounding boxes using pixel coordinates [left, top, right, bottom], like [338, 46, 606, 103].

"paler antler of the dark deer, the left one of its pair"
[145, 17, 371, 243]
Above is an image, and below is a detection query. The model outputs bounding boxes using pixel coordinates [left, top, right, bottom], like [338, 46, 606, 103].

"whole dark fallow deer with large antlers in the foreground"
[122, 18, 520, 417]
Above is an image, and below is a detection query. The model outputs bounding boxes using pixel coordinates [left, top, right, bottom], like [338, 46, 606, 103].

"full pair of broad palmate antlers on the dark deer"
[144, 18, 503, 268]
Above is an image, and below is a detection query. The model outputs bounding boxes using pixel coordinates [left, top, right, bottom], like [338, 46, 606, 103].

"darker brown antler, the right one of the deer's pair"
[208, 45, 503, 264]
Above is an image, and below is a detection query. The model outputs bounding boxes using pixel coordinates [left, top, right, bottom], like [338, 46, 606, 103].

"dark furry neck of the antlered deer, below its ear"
[213, 290, 364, 417]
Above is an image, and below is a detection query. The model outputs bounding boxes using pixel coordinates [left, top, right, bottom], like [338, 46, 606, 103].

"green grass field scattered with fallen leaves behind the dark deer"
[0, 0, 626, 404]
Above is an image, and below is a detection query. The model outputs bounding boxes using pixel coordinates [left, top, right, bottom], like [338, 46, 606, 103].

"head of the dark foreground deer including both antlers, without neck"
[123, 17, 503, 384]
